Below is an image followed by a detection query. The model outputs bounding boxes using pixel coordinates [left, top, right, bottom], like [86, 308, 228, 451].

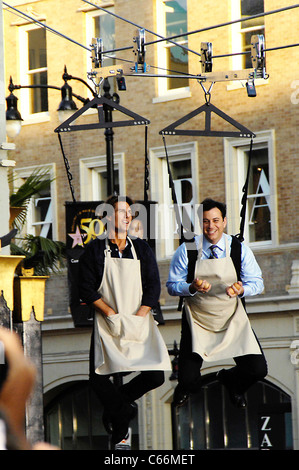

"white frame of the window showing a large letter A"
[224, 130, 279, 248]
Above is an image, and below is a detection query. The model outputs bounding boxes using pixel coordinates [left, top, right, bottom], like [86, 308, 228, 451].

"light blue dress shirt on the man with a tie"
[166, 234, 264, 297]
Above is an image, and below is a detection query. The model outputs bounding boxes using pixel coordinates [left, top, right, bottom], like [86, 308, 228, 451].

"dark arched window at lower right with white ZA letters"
[173, 374, 293, 450]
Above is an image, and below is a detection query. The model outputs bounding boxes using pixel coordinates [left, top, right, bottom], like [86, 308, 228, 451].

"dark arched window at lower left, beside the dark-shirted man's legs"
[44, 381, 139, 450]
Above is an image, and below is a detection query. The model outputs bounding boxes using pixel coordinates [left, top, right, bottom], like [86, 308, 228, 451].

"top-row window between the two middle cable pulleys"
[157, 0, 189, 96]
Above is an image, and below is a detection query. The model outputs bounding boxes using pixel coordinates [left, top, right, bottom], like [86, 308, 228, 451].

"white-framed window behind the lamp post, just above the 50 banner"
[80, 154, 125, 201]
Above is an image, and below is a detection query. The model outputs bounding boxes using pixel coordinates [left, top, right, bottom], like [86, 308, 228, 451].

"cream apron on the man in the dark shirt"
[94, 237, 171, 374]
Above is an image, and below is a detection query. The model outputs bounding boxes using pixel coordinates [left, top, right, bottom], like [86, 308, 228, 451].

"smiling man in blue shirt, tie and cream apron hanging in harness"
[166, 199, 267, 408]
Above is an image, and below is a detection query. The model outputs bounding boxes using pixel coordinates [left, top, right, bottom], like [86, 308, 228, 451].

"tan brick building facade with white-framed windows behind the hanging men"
[3, 0, 299, 450]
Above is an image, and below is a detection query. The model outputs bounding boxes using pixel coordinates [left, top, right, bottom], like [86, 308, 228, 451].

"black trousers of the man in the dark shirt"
[89, 335, 164, 416]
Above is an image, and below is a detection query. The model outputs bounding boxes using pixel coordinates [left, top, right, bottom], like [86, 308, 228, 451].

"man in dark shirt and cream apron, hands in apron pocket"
[79, 196, 171, 444]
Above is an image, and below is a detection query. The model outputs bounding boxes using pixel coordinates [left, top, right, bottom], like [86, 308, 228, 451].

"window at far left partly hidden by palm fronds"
[14, 165, 56, 240]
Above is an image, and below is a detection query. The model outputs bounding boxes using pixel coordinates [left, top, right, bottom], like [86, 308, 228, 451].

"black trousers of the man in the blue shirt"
[178, 311, 268, 393]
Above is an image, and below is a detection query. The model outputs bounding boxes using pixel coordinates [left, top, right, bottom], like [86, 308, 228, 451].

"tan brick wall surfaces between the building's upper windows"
[4, 0, 299, 311]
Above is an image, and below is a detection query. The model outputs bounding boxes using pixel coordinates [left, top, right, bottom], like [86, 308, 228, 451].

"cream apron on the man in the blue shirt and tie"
[185, 239, 261, 362]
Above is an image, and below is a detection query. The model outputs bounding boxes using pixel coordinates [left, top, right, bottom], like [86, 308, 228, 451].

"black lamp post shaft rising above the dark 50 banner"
[103, 78, 114, 196]
